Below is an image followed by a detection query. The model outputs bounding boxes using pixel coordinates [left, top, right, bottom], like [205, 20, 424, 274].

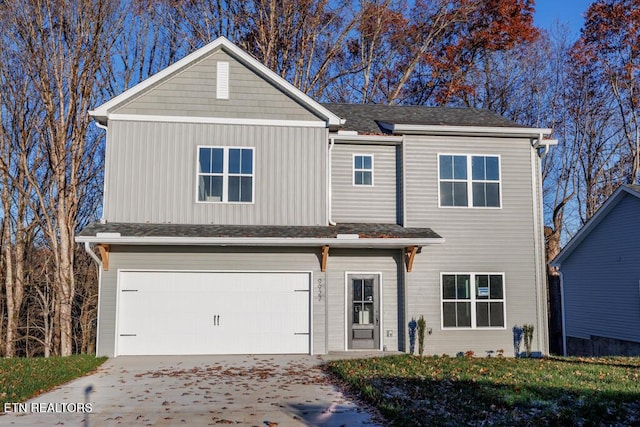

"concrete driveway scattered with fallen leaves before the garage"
[0, 355, 381, 426]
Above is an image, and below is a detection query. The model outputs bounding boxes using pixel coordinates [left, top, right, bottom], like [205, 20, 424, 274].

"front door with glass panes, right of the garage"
[347, 274, 380, 350]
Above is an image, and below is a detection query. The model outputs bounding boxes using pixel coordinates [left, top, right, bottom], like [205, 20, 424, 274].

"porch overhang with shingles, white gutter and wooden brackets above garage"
[76, 223, 445, 272]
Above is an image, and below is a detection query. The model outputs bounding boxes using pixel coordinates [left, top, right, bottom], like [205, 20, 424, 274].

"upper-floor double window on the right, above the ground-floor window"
[438, 154, 501, 208]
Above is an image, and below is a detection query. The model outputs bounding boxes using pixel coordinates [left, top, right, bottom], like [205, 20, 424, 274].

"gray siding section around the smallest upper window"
[331, 144, 401, 224]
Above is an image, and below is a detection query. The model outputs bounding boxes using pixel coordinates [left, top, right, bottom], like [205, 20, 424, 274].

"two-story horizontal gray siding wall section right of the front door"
[404, 136, 547, 356]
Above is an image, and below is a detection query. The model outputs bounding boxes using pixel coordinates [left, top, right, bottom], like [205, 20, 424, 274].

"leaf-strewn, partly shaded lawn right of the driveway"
[328, 355, 640, 426]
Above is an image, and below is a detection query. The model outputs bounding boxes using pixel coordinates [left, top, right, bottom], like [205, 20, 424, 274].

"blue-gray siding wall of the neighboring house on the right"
[561, 194, 640, 342]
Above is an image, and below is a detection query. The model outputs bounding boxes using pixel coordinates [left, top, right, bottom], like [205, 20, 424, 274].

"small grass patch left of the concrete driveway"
[0, 354, 107, 408]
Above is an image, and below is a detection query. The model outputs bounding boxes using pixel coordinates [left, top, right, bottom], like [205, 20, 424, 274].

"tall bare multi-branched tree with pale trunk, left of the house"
[2, 0, 119, 356]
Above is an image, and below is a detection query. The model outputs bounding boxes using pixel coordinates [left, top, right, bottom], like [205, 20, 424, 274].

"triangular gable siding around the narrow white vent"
[110, 50, 320, 121]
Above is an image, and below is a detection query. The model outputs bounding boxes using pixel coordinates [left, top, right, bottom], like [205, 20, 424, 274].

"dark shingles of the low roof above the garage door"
[78, 222, 441, 239]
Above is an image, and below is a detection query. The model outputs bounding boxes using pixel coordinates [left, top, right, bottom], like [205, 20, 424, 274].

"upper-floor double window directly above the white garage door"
[197, 147, 254, 203]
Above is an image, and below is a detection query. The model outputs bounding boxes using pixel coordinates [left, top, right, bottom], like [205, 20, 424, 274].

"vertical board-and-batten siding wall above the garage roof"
[104, 120, 327, 225]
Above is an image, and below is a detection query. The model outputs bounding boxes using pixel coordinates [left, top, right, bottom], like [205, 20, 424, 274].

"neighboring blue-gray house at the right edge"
[551, 185, 640, 356]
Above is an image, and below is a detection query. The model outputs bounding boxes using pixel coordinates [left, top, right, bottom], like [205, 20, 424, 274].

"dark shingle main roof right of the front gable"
[322, 103, 525, 134]
